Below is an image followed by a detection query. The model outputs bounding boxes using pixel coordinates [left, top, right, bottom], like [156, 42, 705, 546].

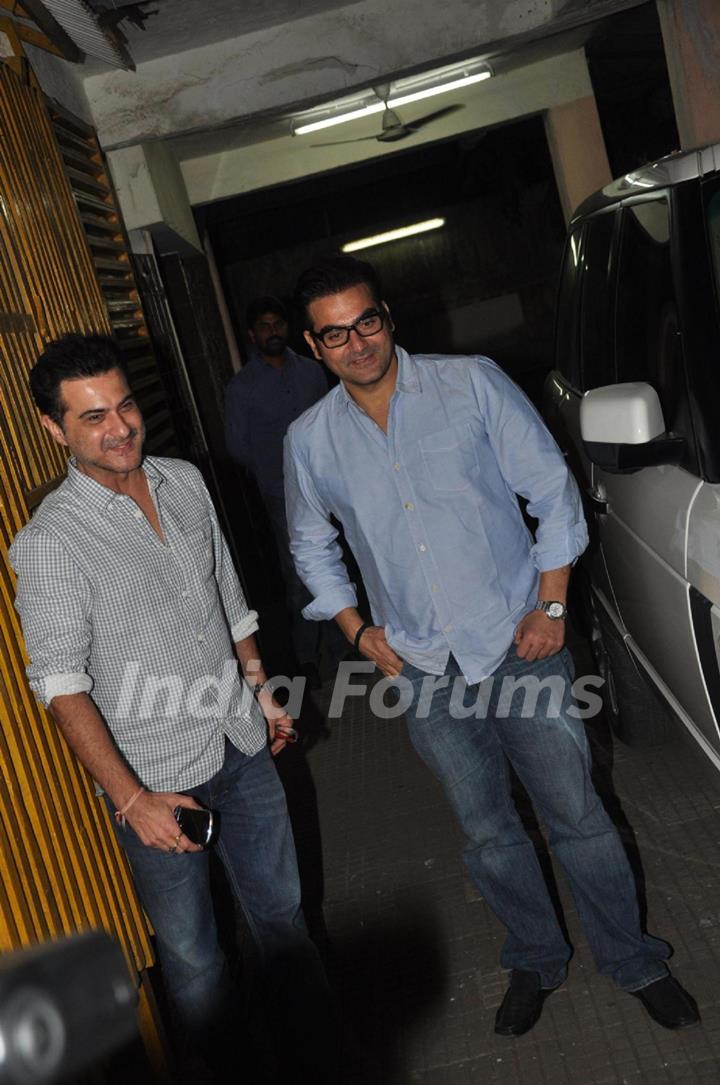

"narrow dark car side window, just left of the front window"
[580, 213, 616, 392]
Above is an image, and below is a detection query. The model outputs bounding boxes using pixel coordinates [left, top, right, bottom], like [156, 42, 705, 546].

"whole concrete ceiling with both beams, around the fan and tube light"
[85, 0, 659, 215]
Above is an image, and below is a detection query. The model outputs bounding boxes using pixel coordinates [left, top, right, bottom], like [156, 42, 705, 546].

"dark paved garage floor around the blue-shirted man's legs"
[288, 646, 720, 1085]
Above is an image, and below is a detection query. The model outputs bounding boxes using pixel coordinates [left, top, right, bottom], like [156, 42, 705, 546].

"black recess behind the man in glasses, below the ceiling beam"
[196, 117, 565, 407]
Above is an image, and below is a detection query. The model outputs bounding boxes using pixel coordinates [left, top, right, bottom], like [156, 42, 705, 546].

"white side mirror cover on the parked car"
[580, 381, 666, 445]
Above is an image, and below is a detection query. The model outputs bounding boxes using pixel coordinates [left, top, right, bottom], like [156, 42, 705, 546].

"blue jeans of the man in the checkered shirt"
[108, 742, 332, 1044]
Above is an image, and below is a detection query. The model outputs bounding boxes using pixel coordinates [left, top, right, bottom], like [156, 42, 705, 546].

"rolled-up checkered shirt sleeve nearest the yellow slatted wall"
[10, 525, 92, 707]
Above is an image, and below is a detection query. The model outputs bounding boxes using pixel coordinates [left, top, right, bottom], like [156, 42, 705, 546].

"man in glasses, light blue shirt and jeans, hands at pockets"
[285, 251, 698, 1035]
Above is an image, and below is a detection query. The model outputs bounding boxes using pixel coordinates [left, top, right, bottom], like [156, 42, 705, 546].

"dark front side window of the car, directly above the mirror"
[616, 197, 686, 432]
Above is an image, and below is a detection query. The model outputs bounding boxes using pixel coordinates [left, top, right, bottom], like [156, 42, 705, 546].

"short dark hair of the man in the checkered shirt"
[29, 335, 128, 425]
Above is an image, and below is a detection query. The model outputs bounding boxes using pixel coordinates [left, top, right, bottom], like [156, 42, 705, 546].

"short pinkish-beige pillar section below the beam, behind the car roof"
[545, 94, 612, 222]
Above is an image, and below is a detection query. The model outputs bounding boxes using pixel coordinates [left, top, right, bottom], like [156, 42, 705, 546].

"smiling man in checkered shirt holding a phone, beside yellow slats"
[11, 335, 329, 1080]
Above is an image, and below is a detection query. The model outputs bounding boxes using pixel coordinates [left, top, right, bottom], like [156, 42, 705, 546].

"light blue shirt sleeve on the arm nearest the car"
[476, 363, 588, 573]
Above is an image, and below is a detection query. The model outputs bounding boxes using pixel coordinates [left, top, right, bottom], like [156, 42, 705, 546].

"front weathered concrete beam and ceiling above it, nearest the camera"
[85, 0, 642, 152]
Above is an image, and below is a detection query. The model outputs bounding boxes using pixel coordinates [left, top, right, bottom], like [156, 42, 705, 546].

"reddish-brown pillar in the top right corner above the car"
[657, 0, 720, 150]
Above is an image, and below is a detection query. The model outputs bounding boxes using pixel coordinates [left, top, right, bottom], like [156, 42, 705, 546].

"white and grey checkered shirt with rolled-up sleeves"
[10, 457, 267, 791]
